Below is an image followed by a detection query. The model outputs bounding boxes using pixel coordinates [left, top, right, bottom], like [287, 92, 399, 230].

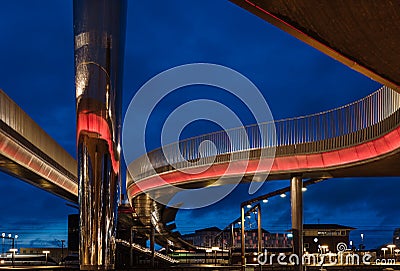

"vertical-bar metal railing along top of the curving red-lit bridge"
[128, 86, 400, 185]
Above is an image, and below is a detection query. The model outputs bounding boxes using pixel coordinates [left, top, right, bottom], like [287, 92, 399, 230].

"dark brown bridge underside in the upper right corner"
[230, 0, 400, 92]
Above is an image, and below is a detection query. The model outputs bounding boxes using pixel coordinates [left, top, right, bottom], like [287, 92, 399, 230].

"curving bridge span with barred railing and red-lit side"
[127, 87, 400, 199]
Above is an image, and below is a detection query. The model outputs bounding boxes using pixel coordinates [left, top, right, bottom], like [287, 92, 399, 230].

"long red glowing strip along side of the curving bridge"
[128, 126, 400, 198]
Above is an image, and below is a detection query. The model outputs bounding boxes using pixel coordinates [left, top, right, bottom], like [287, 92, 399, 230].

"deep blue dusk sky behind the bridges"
[0, 0, 400, 251]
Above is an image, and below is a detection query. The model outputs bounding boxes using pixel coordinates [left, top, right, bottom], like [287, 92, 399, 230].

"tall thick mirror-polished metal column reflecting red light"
[74, 0, 126, 270]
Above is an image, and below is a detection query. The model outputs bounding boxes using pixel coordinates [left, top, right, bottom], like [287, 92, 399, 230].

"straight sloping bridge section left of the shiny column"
[0, 90, 78, 202]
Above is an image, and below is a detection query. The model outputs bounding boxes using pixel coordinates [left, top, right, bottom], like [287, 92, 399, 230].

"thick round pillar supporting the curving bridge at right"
[290, 176, 303, 271]
